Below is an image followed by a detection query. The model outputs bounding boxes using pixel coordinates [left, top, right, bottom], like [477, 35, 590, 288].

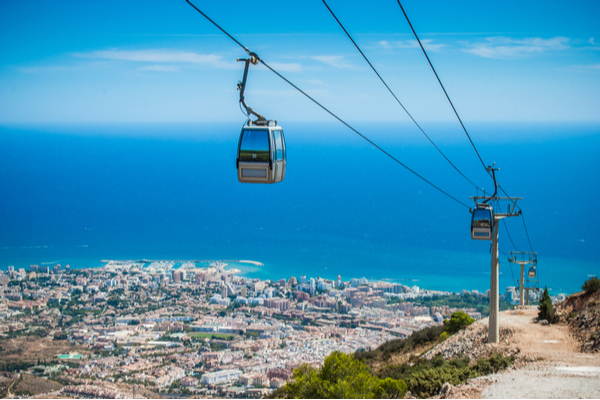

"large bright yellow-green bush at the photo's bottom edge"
[272, 351, 407, 399]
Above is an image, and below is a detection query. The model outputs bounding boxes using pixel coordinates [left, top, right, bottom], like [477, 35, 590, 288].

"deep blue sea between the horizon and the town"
[0, 122, 600, 294]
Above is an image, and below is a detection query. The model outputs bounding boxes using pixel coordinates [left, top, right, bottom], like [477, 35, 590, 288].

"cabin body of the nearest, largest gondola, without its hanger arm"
[237, 126, 286, 183]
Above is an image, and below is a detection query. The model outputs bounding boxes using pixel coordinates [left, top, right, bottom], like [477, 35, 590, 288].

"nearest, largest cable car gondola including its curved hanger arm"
[236, 53, 286, 183]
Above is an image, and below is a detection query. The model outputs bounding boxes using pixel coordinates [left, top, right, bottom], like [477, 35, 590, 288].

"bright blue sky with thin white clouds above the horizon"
[0, 0, 600, 124]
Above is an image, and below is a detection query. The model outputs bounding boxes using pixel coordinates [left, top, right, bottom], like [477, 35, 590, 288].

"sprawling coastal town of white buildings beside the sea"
[0, 260, 532, 398]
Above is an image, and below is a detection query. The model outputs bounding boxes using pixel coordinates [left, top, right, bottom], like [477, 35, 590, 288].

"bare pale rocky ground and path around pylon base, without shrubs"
[427, 307, 600, 399]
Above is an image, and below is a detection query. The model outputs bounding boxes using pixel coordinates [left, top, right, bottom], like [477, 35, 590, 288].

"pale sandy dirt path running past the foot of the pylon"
[449, 308, 600, 399]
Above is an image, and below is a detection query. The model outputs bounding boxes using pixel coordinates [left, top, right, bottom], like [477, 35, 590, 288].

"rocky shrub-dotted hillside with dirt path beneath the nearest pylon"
[356, 292, 600, 398]
